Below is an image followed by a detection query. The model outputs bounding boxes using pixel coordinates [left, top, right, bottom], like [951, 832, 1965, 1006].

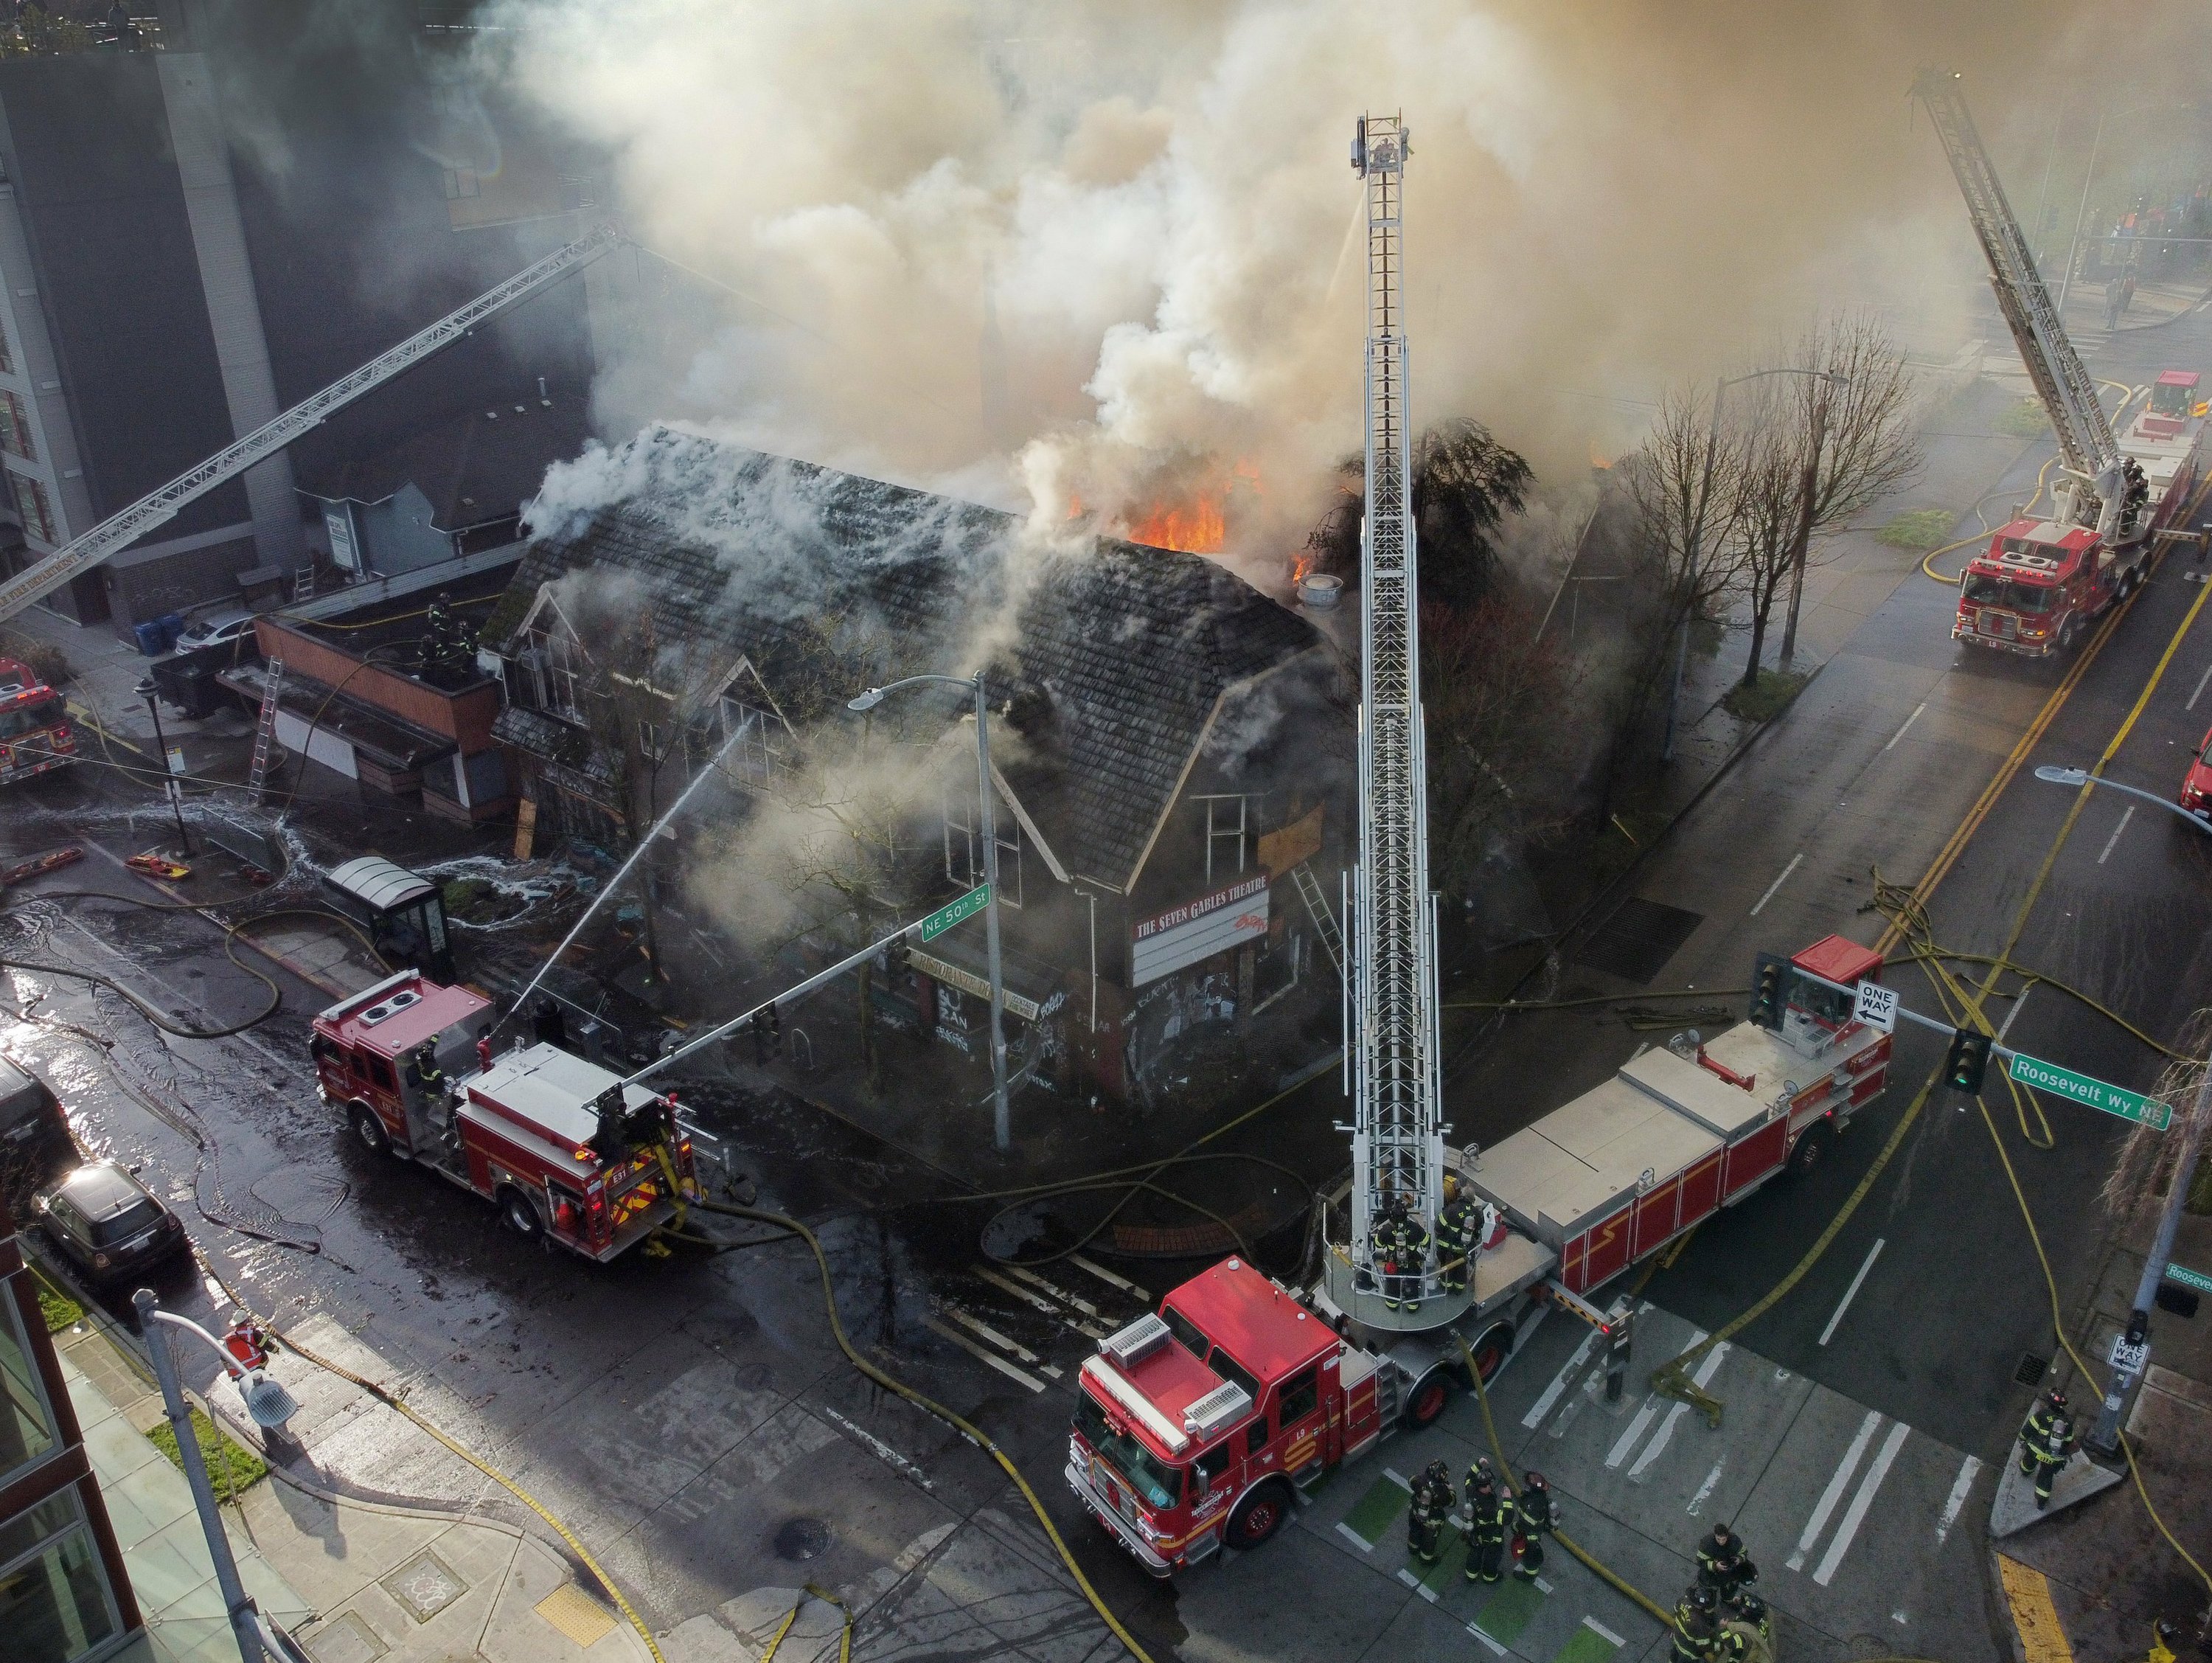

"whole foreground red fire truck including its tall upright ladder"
[1066, 117, 1889, 1577]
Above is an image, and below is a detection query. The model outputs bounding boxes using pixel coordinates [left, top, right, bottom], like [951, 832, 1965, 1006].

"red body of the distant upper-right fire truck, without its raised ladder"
[1951, 369, 2205, 659]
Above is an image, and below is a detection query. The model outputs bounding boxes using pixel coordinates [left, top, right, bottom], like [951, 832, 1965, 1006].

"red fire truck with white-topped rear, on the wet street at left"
[307, 971, 699, 1265]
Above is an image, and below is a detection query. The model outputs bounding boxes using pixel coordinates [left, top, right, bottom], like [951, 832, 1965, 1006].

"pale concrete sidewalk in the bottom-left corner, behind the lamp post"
[55, 1316, 648, 1663]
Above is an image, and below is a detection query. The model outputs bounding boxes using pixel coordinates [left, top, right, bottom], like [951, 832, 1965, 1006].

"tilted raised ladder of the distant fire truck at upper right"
[1913, 69, 2130, 546]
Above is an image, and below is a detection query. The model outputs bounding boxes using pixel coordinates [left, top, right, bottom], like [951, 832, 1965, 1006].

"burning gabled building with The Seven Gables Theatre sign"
[484, 427, 1354, 1099]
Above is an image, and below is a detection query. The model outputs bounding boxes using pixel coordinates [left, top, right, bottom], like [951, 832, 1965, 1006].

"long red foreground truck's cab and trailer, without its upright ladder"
[1066, 935, 1889, 1577]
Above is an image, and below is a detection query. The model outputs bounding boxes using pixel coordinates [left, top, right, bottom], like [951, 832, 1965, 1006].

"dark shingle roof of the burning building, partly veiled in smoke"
[484, 427, 1321, 886]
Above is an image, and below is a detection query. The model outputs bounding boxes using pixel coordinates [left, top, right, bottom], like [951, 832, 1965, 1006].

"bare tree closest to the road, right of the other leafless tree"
[1745, 312, 1922, 667]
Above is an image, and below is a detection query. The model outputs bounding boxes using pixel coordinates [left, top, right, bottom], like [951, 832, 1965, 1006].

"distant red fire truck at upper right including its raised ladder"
[1913, 69, 2205, 657]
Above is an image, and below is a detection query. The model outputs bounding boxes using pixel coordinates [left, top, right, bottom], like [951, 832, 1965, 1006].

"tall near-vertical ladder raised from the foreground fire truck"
[1329, 115, 1467, 1329]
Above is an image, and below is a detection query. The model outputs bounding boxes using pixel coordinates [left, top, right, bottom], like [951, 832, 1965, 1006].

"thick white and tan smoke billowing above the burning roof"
[484, 0, 2212, 559]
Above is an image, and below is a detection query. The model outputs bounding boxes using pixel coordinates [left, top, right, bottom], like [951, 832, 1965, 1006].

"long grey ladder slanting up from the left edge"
[0, 223, 622, 624]
